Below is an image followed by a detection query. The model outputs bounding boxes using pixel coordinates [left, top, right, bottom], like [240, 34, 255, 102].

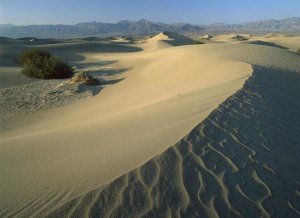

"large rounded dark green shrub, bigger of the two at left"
[19, 49, 73, 79]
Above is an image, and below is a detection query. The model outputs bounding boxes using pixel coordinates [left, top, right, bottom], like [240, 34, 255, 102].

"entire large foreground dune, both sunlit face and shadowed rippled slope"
[0, 31, 300, 217]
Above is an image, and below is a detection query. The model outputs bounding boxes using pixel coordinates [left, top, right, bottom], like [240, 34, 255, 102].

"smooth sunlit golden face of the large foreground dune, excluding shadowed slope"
[0, 34, 252, 216]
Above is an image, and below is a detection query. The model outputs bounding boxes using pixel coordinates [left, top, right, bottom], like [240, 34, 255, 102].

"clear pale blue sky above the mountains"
[0, 0, 300, 25]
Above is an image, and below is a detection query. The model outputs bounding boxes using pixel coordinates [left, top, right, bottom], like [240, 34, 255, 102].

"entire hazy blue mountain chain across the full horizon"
[0, 17, 300, 38]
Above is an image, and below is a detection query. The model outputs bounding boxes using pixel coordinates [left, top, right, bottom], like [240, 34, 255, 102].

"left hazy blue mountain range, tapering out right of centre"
[0, 20, 203, 38]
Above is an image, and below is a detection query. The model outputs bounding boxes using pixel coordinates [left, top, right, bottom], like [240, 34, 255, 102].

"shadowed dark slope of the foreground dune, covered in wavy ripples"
[49, 45, 300, 218]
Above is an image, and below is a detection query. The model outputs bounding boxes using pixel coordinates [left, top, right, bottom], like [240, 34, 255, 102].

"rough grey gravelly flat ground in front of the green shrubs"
[0, 80, 96, 123]
